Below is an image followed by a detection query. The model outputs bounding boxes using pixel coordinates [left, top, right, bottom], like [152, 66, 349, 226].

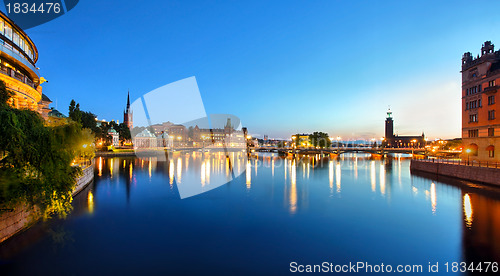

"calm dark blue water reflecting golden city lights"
[0, 153, 500, 275]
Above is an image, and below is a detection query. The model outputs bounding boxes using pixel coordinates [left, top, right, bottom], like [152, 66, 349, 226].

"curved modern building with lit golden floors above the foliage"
[0, 12, 42, 111]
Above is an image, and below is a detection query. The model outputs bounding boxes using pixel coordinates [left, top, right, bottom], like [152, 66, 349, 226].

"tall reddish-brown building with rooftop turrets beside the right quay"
[461, 41, 500, 161]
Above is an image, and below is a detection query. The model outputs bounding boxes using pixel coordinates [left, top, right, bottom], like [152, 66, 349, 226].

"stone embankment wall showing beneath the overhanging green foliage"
[0, 165, 94, 243]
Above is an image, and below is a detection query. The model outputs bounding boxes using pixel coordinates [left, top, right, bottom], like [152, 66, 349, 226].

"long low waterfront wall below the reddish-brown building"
[410, 160, 500, 186]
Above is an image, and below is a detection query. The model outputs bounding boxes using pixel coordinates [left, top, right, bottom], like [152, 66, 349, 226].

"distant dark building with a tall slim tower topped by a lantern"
[383, 109, 425, 148]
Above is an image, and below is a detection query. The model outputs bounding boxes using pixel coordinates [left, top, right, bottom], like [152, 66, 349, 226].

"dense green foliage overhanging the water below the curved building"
[0, 82, 94, 218]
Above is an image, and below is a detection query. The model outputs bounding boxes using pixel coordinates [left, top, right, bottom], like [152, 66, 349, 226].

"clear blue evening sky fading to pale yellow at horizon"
[6, 0, 500, 139]
